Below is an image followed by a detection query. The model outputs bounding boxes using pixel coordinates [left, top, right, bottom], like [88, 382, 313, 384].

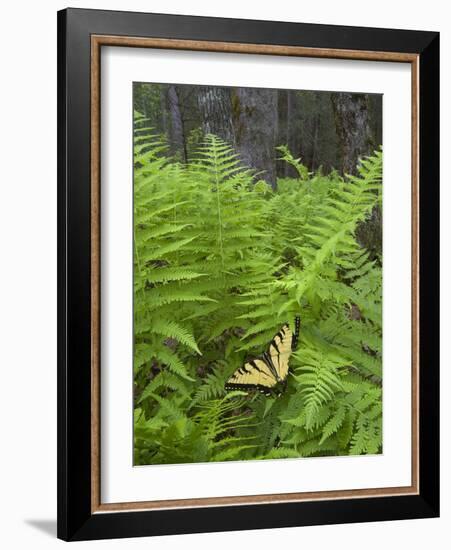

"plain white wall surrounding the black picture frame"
[0, 0, 451, 550]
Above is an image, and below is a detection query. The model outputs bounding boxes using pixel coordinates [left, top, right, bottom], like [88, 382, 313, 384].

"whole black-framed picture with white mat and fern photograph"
[58, 9, 439, 540]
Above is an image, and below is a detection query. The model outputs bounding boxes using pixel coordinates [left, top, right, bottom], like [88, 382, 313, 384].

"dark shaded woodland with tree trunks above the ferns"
[134, 83, 382, 183]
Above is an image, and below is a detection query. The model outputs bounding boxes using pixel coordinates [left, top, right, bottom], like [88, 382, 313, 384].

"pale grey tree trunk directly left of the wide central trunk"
[197, 86, 235, 145]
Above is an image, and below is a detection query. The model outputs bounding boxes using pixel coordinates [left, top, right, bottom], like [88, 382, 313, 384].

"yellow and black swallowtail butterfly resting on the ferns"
[225, 317, 301, 395]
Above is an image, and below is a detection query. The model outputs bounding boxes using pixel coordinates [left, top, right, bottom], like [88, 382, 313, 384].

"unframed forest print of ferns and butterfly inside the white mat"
[130, 82, 383, 466]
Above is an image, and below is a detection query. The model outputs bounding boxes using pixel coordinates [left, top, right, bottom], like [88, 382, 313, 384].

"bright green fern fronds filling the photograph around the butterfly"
[134, 113, 382, 464]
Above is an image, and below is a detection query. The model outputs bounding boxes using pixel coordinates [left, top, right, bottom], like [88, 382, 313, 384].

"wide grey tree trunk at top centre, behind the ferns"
[232, 88, 278, 189]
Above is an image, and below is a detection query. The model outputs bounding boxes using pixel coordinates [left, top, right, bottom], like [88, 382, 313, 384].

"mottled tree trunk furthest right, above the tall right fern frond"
[331, 93, 375, 174]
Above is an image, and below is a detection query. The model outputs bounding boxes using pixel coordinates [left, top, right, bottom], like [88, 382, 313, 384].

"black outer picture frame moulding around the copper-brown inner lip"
[58, 9, 439, 540]
